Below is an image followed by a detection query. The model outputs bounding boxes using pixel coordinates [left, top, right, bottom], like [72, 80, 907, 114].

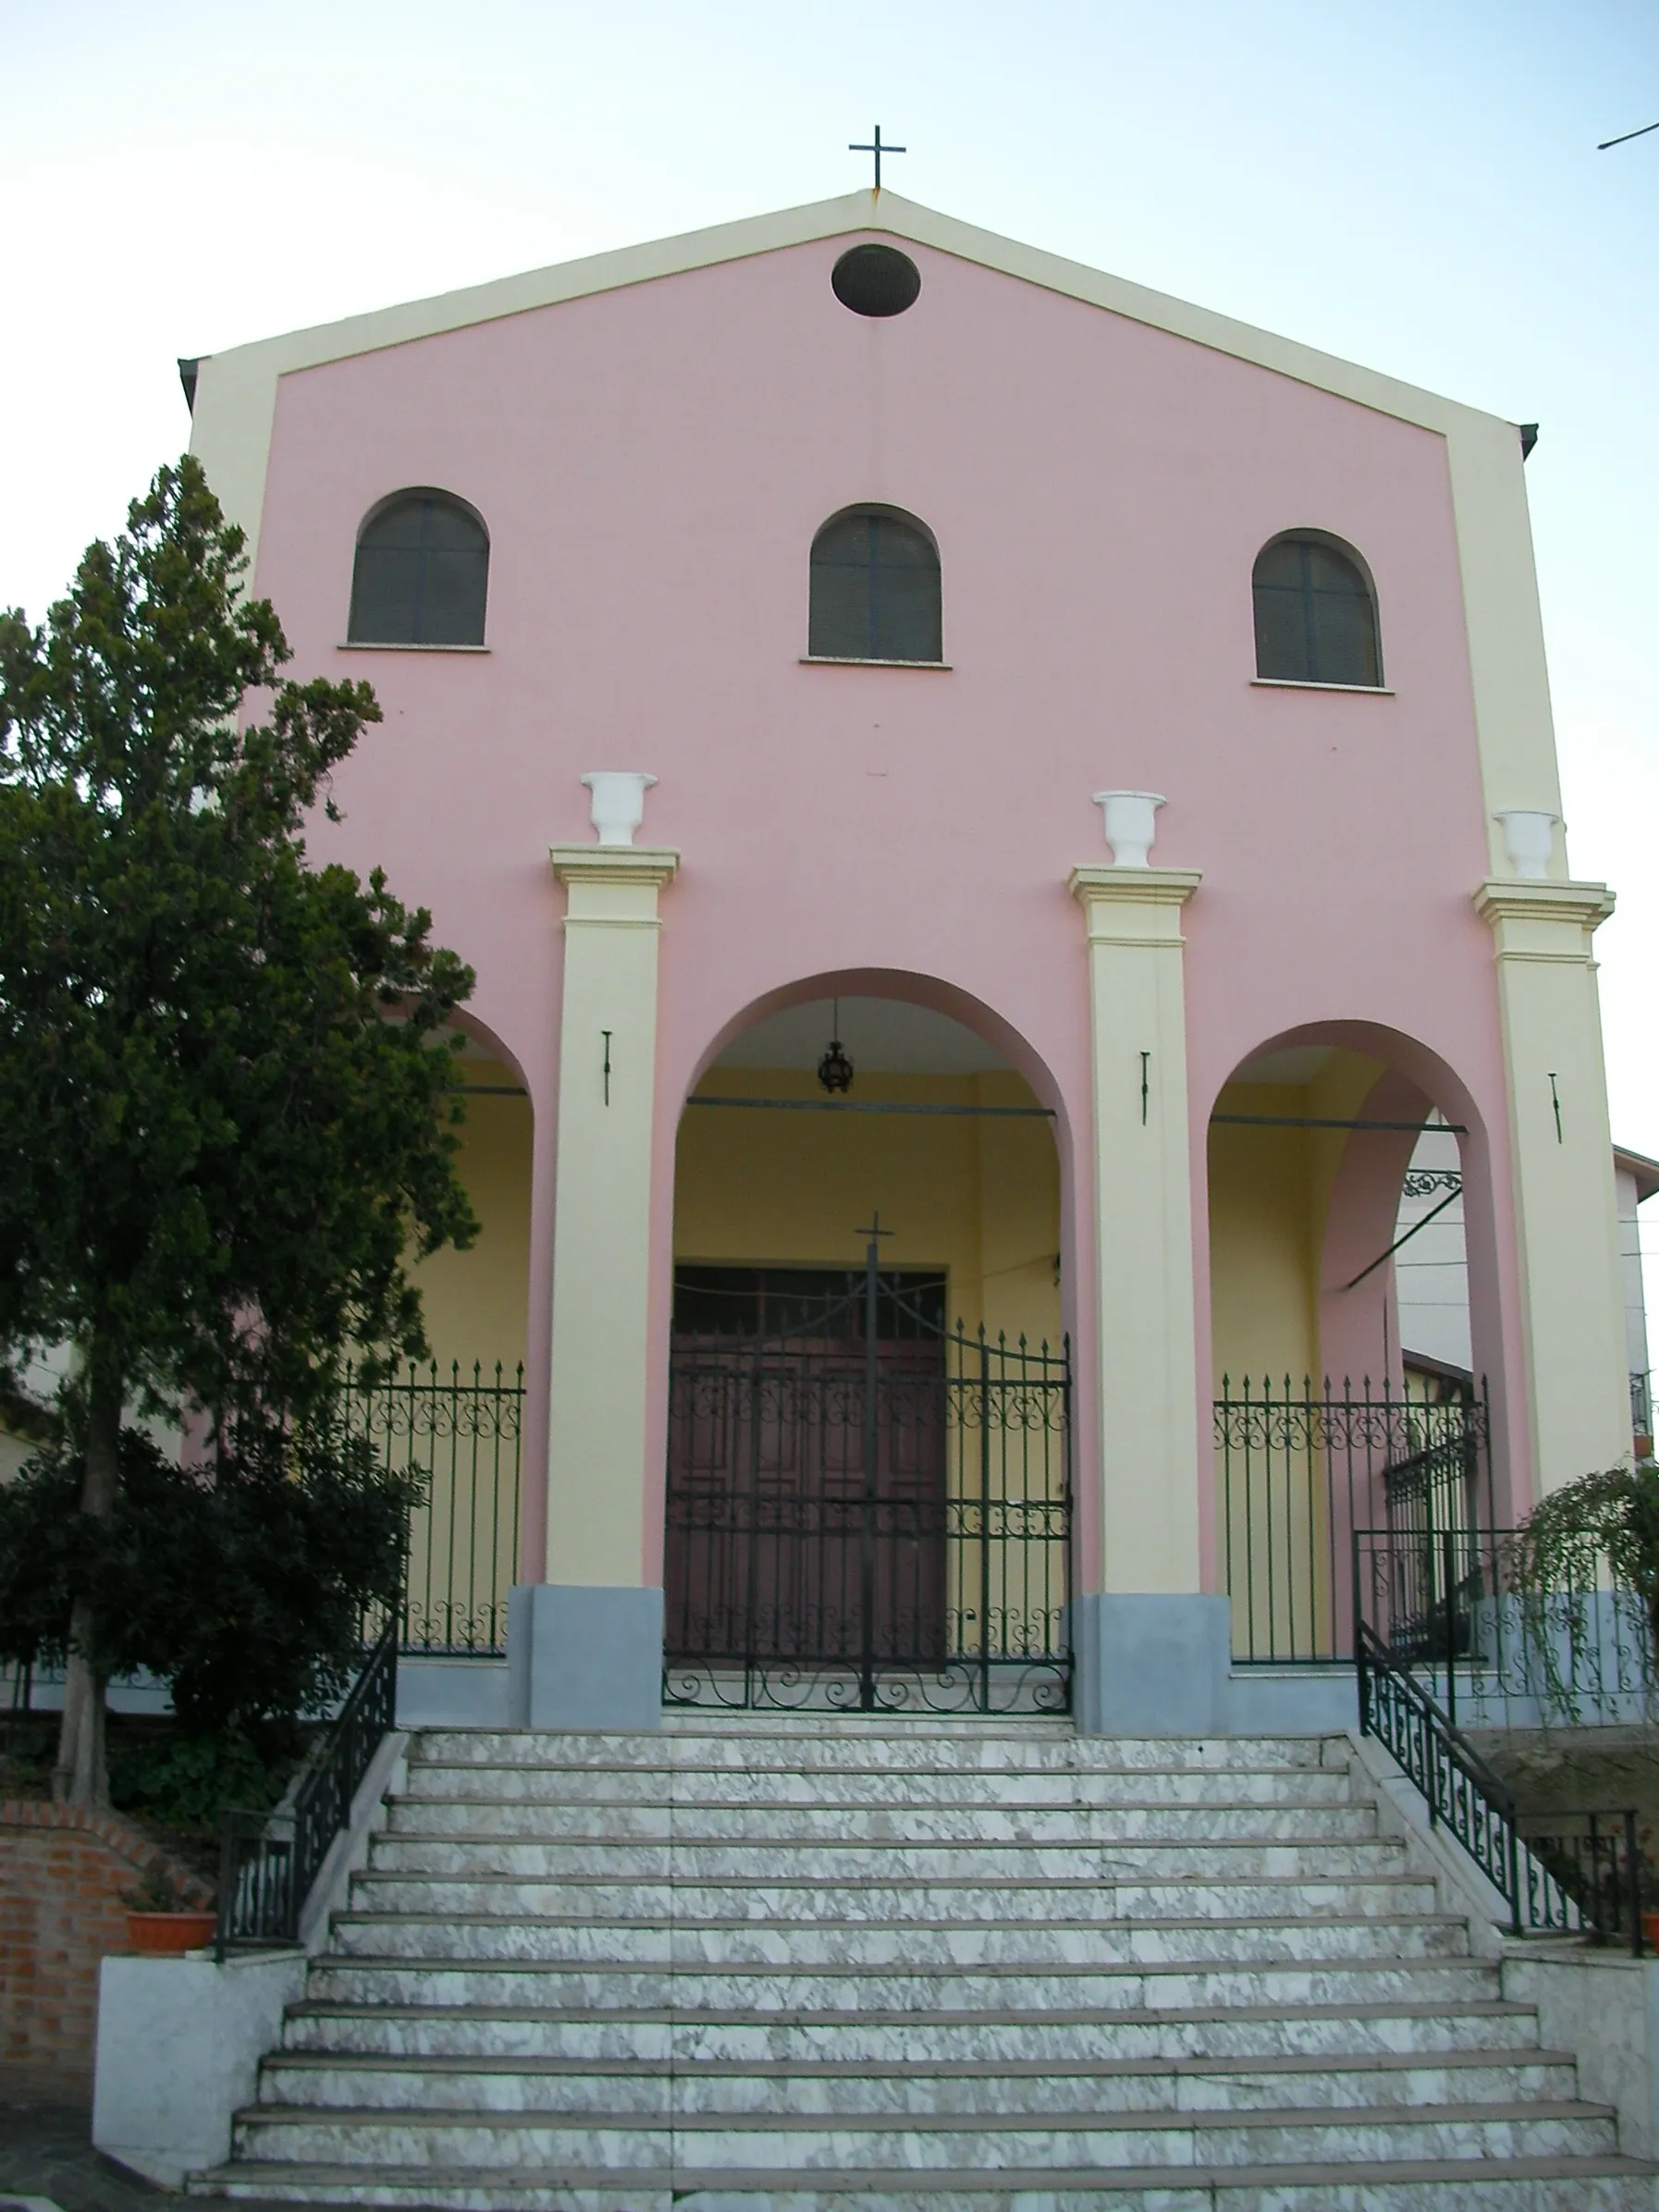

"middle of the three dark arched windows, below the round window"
[807, 507, 944, 661]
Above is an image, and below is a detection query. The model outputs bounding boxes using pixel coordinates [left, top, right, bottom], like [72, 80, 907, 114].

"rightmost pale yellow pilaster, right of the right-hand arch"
[1475, 880, 1630, 1505]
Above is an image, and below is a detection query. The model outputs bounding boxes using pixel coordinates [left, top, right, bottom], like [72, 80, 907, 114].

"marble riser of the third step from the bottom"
[259, 2050, 1575, 2121]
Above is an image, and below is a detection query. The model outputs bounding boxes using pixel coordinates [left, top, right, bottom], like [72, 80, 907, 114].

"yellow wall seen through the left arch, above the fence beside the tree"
[413, 1060, 531, 1381]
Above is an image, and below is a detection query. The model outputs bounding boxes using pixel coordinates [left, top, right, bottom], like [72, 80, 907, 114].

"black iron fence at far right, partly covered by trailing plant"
[1354, 1529, 1659, 1730]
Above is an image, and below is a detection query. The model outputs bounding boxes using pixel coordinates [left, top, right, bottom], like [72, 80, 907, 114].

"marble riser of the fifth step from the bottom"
[307, 1953, 1493, 2018]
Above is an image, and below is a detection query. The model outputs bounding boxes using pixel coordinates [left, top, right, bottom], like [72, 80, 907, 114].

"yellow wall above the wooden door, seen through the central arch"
[675, 1068, 1060, 1345]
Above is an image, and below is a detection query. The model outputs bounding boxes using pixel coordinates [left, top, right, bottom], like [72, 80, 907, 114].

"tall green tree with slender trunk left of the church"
[0, 458, 475, 1802]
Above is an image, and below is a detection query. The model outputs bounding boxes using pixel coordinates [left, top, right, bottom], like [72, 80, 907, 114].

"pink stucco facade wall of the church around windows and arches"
[246, 241, 1524, 1581]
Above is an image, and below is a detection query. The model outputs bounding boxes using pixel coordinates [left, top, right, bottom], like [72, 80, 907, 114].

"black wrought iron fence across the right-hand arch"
[1214, 1376, 1493, 1665]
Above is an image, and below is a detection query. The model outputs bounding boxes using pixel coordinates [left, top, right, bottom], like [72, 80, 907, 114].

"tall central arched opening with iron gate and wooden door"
[661, 969, 1073, 1712]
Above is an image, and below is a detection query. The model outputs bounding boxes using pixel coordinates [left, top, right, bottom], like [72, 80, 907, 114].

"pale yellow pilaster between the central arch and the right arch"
[1071, 867, 1201, 1595]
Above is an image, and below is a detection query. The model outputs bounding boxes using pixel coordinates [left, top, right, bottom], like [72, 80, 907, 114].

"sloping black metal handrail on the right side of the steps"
[1354, 1610, 1643, 1958]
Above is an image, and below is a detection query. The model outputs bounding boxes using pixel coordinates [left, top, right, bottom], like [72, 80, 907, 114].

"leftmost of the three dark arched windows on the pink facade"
[345, 491, 489, 645]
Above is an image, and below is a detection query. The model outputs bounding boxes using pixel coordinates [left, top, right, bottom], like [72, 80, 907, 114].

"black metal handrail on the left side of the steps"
[215, 1613, 399, 1960]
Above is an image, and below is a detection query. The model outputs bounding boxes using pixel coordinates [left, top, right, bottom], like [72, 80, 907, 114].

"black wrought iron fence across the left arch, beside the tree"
[345, 1360, 524, 1657]
